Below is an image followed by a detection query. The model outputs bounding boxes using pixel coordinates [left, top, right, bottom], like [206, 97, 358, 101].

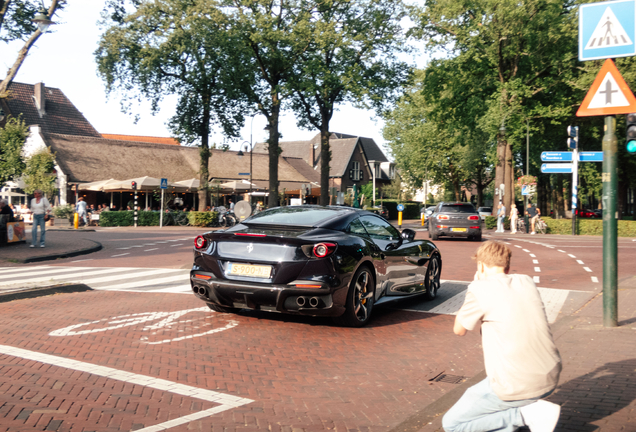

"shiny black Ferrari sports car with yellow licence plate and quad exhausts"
[190, 205, 442, 327]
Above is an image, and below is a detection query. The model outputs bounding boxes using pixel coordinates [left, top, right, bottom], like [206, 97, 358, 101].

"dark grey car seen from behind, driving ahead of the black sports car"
[428, 202, 481, 241]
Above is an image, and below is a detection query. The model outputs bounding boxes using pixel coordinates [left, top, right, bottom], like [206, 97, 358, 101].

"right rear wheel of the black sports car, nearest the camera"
[334, 267, 374, 327]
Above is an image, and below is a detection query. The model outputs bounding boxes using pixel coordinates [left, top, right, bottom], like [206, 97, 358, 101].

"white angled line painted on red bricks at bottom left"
[0, 345, 254, 432]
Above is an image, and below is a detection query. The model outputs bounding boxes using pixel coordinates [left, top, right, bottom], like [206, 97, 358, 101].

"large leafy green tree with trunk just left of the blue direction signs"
[414, 0, 580, 214]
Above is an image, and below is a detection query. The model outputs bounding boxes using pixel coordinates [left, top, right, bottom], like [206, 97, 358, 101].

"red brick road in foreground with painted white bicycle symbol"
[0, 291, 482, 432]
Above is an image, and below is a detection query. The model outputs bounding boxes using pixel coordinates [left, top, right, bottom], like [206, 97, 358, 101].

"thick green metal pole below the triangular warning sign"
[603, 116, 618, 327]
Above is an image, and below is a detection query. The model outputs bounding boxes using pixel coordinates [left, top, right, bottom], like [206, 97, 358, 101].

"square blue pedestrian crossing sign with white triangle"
[579, 0, 636, 61]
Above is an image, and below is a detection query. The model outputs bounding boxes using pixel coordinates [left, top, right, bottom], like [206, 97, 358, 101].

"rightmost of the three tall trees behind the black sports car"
[290, 0, 410, 205]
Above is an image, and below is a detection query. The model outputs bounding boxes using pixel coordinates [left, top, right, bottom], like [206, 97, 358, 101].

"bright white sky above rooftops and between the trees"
[0, 0, 428, 154]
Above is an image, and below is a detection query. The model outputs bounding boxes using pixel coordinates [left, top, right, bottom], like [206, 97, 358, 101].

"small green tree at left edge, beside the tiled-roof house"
[0, 117, 29, 188]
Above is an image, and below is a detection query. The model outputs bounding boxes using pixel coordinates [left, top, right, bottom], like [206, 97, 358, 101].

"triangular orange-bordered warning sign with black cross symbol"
[576, 59, 636, 117]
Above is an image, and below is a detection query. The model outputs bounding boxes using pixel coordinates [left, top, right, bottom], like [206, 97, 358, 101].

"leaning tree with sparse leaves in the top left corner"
[0, 0, 66, 98]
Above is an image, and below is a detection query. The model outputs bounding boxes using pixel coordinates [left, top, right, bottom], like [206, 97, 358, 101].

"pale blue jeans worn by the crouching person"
[442, 378, 540, 432]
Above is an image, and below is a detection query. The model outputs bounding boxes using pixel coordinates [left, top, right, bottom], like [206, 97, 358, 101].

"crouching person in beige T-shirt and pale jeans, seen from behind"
[442, 241, 562, 432]
